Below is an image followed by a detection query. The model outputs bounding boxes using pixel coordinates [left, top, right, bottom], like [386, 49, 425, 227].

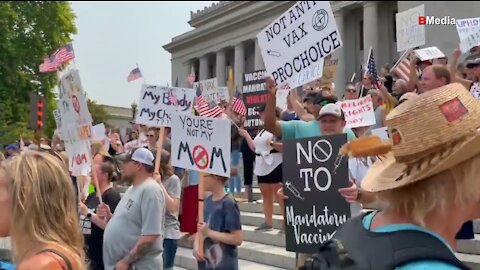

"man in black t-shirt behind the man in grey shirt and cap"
[79, 161, 121, 270]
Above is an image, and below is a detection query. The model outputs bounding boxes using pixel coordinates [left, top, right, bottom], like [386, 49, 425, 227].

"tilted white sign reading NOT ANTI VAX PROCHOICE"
[257, 1, 342, 88]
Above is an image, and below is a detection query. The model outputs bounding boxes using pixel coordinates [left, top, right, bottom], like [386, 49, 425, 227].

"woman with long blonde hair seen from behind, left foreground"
[0, 151, 86, 270]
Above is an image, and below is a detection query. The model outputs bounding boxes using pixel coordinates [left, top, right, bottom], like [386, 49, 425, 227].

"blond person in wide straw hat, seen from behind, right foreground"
[336, 83, 480, 269]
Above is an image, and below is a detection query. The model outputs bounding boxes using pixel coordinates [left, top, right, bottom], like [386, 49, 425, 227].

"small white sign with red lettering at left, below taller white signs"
[65, 141, 92, 176]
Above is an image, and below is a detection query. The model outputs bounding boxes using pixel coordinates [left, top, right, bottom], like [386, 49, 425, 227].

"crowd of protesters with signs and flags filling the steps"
[0, 2, 480, 270]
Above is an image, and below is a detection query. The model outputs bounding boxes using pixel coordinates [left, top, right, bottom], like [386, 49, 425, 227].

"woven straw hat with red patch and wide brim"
[342, 83, 480, 192]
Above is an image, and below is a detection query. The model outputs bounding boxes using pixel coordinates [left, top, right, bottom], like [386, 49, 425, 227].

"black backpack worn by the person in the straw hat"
[299, 213, 470, 270]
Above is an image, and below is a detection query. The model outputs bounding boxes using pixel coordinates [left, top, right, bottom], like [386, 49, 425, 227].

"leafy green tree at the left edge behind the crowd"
[0, 1, 77, 144]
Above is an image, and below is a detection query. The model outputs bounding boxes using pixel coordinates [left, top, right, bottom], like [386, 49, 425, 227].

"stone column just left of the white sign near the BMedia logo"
[362, 1, 378, 65]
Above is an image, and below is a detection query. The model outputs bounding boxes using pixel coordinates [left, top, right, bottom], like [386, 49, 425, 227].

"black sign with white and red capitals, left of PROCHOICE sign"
[242, 70, 268, 129]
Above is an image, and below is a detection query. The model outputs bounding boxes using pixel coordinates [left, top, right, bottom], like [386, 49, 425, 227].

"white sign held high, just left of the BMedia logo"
[395, 5, 425, 52]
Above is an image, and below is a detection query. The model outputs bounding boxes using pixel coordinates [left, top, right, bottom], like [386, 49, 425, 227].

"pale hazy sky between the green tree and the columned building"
[72, 1, 215, 107]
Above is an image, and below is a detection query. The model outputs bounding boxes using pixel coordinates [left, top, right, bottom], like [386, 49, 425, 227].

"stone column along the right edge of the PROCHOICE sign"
[334, 10, 344, 98]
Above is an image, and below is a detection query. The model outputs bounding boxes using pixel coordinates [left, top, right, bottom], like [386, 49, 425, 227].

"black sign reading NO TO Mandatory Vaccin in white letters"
[283, 134, 350, 253]
